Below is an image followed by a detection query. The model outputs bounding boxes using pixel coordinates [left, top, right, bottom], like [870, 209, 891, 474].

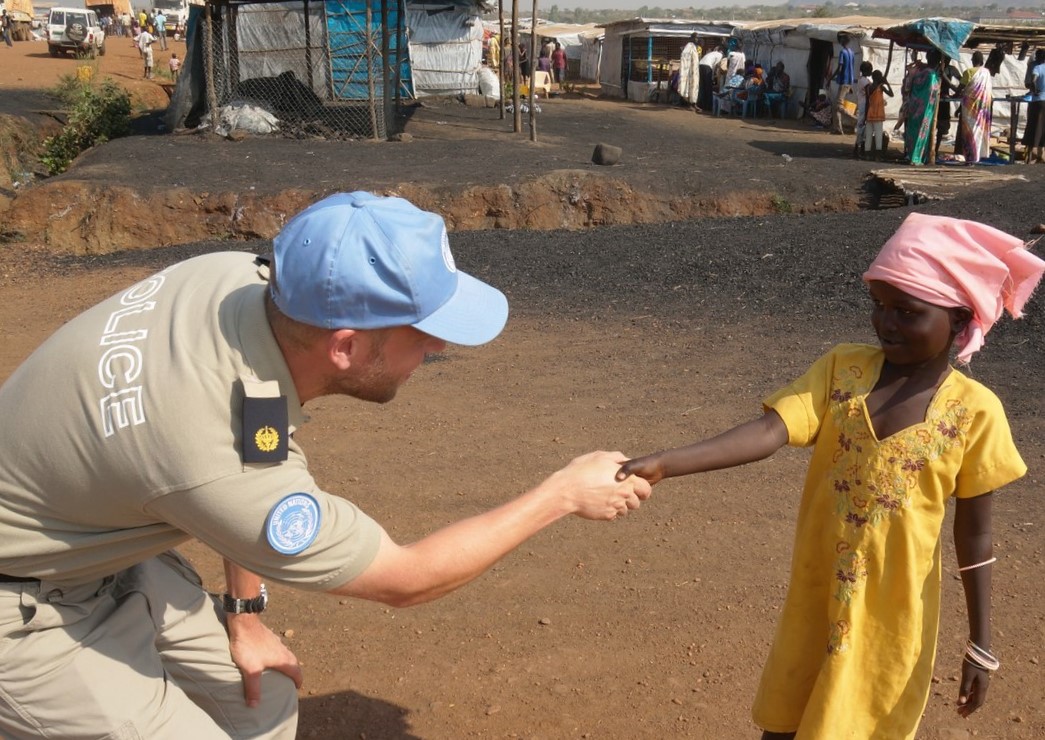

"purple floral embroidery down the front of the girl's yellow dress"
[828, 361, 972, 655]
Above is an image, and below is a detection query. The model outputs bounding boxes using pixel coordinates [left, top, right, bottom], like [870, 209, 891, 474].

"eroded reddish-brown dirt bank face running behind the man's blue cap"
[4, 163, 857, 254]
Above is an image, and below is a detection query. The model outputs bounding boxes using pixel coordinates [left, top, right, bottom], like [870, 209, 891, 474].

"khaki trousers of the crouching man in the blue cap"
[0, 552, 298, 740]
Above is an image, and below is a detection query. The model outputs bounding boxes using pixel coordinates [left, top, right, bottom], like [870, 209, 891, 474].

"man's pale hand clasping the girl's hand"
[551, 452, 652, 519]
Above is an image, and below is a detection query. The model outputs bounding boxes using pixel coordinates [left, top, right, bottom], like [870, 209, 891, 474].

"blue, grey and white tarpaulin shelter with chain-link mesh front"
[166, 0, 483, 138]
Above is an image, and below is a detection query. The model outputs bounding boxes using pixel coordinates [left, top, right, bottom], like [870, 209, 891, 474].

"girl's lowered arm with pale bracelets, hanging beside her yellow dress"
[954, 493, 994, 717]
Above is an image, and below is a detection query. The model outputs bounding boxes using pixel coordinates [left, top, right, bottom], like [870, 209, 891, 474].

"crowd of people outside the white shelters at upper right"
[669, 33, 1045, 165]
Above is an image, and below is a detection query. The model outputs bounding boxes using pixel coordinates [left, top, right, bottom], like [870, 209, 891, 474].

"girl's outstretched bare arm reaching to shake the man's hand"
[617, 410, 787, 483]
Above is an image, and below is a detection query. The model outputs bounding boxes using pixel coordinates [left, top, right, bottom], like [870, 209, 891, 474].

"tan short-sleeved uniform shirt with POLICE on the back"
[0, 252, 380, 589]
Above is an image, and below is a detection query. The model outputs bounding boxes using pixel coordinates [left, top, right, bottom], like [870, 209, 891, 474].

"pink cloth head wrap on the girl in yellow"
[863, 213, 1045, 363]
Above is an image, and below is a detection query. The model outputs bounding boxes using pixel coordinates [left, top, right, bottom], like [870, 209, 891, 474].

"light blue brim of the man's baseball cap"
[413, 271, 508, 346]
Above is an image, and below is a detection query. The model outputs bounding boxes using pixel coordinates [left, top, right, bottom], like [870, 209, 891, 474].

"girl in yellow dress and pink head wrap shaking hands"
[618, 213, 1045, 740]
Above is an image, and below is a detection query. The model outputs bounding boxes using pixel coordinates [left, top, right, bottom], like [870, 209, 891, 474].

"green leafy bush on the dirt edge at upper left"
[40, 75, 131, 175]
